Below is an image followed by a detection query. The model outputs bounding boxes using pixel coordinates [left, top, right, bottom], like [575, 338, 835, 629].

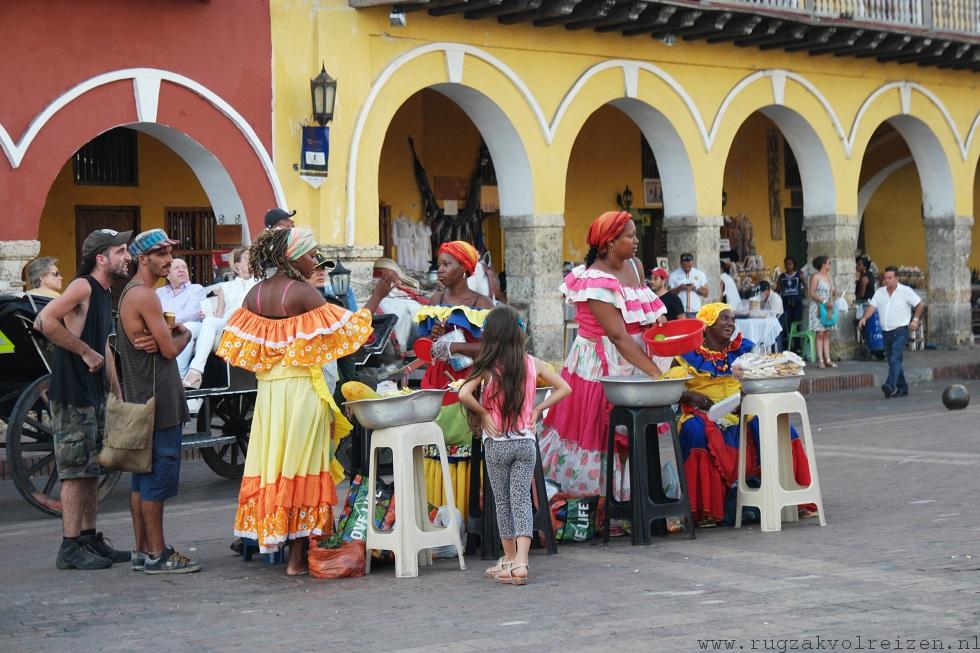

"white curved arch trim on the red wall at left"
[0, 68, 288, 208]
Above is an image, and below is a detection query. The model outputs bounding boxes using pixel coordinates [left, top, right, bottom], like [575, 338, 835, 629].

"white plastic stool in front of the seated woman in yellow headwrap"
[735, 392, 827, 533]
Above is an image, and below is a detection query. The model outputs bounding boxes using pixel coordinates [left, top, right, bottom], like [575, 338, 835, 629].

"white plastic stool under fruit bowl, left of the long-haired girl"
[364, 422, 466, 578]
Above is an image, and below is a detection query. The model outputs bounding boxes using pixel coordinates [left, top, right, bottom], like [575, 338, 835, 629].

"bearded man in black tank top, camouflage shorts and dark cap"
[34, 229, 140, 569]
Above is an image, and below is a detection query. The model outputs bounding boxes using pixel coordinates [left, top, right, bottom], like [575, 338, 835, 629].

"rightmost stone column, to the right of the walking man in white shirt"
[925, 215, 973, 349]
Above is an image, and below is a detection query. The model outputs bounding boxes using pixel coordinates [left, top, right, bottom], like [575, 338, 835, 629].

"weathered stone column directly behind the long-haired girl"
[500, 215, 565, 361]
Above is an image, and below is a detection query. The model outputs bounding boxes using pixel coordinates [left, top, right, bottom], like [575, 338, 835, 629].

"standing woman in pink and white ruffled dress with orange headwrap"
[541, 211, 671, 496]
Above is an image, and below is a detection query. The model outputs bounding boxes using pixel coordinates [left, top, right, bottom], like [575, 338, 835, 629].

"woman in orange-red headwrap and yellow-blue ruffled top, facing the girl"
[416, 240, 493, 519]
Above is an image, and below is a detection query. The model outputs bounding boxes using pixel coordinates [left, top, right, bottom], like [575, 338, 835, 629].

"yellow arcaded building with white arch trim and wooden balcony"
[264, 0, 980, 357]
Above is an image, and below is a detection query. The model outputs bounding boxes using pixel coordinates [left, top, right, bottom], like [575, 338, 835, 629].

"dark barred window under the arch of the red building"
[72, 127, 139, 186]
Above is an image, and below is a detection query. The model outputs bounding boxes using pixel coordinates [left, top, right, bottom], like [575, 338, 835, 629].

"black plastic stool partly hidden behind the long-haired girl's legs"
[466, 438, 558, 560]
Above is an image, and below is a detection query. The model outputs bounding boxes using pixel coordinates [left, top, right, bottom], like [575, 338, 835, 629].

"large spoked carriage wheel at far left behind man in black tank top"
[6, 374, 120, 517]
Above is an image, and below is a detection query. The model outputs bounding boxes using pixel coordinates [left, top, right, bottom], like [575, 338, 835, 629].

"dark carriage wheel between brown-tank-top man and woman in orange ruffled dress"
[197, 392, 255, 479]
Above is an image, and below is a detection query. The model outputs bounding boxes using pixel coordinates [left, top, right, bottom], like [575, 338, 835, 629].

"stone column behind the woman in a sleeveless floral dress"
[800, 215, 861, 359]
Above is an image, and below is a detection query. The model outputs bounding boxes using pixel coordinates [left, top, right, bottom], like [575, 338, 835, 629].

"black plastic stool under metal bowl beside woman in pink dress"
[602, 406, 695, 546]
